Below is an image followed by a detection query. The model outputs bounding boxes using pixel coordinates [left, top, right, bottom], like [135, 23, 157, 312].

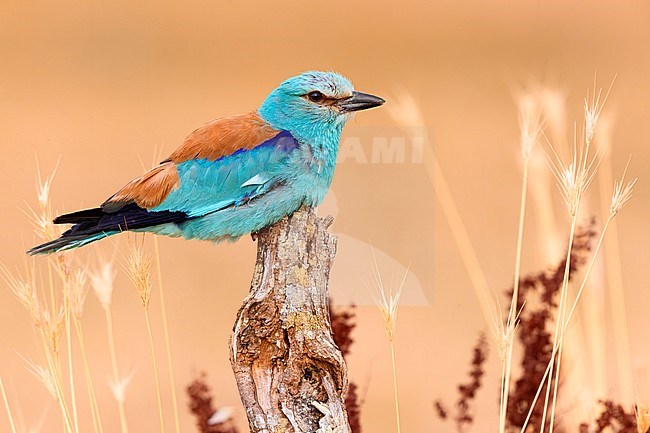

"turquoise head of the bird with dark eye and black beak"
[259, 71, 385, 138]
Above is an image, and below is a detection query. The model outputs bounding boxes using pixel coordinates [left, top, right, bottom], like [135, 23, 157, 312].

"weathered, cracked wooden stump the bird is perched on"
[230, 208, 350, 433]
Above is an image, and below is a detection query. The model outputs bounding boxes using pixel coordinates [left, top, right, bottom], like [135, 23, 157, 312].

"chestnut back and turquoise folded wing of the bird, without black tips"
[102, 114, 298, 218]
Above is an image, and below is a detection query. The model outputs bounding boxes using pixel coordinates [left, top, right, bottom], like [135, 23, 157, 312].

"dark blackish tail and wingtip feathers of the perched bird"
[27, 203, 187, 256]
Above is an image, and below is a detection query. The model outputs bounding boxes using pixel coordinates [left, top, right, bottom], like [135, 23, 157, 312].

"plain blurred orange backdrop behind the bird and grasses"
[0, 0, 650, 432]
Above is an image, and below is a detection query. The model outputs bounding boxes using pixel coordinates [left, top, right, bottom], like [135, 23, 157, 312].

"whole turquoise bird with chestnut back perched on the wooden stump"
[28, 71, 384, 255]
